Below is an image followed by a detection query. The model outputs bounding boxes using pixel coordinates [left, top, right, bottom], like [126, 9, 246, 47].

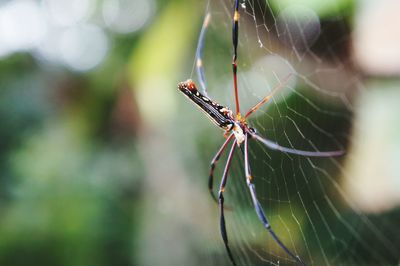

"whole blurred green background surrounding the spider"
[0, 0, 400, 266]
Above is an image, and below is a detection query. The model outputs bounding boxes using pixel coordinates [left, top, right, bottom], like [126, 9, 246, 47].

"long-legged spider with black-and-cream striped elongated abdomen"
[178, 0, 344, 265]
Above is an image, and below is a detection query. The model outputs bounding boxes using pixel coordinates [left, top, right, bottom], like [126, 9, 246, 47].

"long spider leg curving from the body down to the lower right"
[243, 134, 306, 265]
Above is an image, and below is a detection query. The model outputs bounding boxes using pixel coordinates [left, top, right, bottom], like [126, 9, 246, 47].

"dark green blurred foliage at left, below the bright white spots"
[0, 4, 145, 265]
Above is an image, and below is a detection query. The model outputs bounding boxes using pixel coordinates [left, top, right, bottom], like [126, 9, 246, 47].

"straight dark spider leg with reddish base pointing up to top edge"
[232, 0, 240, 114]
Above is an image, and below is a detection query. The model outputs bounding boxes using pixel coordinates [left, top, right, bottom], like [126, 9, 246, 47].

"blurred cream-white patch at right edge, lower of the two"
[342, 87, 400, 213]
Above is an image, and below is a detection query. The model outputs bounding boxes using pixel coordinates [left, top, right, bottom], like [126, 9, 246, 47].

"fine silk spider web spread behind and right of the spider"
[192, 0, 400, 265]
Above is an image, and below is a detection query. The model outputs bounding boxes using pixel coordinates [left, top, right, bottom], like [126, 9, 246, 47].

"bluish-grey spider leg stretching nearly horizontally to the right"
[250, 133, 344, 157]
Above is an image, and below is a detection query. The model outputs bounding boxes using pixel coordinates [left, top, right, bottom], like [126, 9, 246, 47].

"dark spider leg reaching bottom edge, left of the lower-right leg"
[218, 140, 236, 265]
